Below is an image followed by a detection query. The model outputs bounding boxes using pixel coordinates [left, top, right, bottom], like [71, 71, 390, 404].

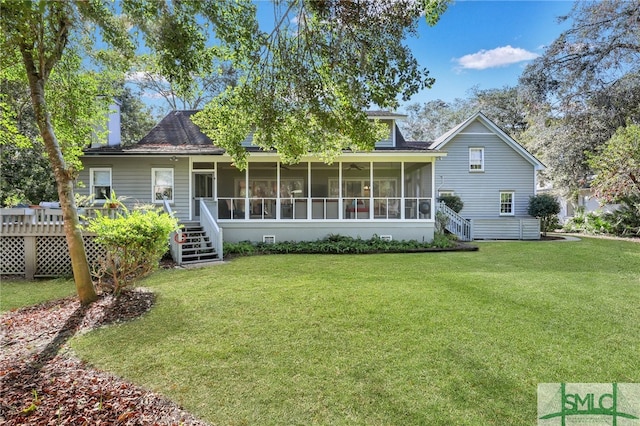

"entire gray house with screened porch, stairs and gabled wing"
[78, 111, 543, 260]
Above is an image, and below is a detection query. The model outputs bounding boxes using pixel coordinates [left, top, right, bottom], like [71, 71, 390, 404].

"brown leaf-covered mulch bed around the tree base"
[0, 289, 206, 426]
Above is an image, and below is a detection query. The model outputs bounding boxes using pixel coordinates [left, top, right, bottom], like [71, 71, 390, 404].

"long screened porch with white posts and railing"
[205, 161, 434, 221]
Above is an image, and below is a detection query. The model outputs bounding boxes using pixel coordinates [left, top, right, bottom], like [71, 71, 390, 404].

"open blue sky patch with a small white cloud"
[400, 0, 574, 110]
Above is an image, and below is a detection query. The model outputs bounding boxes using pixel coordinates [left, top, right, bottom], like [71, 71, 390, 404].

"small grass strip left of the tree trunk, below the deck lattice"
[0, 278, 76, 312]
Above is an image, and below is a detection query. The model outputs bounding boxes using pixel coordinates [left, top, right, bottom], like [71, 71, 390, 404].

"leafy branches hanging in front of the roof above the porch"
[193, 0, 448, 168]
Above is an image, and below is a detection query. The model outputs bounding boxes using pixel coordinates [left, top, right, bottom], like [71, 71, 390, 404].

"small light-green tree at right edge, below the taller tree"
[589, 123, 640, 203]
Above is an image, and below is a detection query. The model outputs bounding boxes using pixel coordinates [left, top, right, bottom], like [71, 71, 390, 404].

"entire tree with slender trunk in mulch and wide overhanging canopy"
[0, 0, 448, 303]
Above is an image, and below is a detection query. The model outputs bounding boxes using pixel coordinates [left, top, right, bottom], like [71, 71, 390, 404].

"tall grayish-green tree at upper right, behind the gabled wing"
[520, 0, 640, 199]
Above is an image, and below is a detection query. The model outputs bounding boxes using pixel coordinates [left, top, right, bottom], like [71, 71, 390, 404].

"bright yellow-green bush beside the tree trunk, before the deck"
[87, 208, 178, 294]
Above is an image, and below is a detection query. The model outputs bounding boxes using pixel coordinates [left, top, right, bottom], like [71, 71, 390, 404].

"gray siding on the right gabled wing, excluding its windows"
[435, 131, 535, 219]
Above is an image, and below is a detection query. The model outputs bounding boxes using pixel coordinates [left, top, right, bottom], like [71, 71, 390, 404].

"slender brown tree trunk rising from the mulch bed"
[28, 73, 98, 305]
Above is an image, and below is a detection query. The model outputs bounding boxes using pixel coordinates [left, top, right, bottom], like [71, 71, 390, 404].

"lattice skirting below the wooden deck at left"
[0, 236, 104, 278]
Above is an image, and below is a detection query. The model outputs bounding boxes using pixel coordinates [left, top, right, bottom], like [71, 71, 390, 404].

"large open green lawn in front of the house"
[8, 239, 640, 425]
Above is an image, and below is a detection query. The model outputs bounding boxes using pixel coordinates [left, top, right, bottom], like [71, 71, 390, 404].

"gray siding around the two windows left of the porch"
[76, 157, 189, 220]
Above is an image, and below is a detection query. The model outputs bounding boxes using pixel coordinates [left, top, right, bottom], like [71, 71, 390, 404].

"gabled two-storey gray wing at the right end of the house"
[430, 112, 544, 240]
